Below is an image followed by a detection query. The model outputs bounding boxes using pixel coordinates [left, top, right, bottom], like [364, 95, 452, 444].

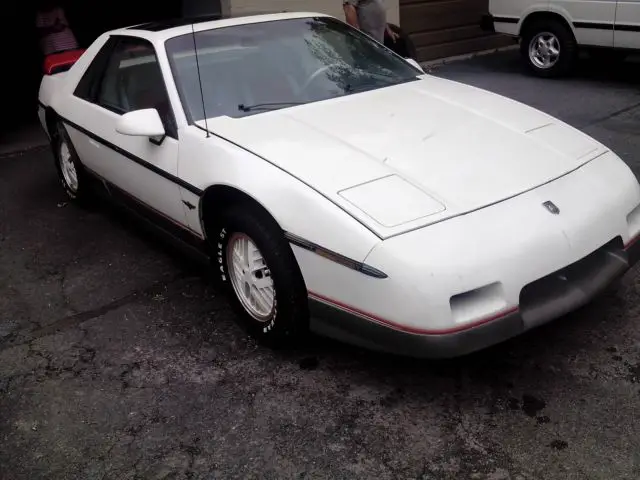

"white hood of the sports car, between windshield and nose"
[202, 75, 607, 238]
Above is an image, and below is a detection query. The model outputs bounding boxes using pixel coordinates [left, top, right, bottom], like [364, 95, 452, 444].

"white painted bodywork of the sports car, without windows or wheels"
[39, 11, 640, 355]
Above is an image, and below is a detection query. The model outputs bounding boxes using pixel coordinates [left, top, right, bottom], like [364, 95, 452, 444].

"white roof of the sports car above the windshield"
[117, 12, 329, 40]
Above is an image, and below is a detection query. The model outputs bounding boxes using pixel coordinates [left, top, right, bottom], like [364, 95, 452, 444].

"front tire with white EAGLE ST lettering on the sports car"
[213, 205, 309, 348]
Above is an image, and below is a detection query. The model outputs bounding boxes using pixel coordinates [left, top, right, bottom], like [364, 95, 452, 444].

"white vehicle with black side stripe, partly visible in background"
[483, 0, 640, 77]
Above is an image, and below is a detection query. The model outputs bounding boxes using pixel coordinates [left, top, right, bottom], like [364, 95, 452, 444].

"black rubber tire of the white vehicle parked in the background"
[520, 19, 578, 78]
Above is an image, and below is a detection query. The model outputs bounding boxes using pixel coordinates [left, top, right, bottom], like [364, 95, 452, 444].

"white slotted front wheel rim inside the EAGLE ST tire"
[226, 233, 276, 323]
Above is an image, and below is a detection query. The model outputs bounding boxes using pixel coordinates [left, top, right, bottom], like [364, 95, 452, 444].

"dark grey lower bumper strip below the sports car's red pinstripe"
[310, 237, 640, 358]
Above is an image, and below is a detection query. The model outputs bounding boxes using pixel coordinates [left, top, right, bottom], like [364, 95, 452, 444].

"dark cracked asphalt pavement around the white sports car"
[0, 52, 640, 480]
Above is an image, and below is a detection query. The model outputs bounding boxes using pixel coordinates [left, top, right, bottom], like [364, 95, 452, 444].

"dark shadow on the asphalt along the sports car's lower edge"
[92, 185, 635, 385]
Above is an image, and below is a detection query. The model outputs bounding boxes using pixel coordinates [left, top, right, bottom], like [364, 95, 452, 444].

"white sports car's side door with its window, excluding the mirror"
[68, 36, 186, 226]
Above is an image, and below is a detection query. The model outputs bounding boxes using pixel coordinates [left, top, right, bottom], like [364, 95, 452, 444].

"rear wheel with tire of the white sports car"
[51, 122, 88, 203]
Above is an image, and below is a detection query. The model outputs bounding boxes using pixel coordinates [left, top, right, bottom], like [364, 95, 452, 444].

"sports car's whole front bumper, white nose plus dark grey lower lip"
[301, 153, 640, 357]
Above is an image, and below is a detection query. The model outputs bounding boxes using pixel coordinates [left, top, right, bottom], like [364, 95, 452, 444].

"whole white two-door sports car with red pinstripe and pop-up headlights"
[39, 13, 640, 357]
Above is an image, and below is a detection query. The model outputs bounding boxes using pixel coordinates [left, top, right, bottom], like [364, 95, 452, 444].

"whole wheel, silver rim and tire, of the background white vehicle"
[520, 19, 578, 78]
